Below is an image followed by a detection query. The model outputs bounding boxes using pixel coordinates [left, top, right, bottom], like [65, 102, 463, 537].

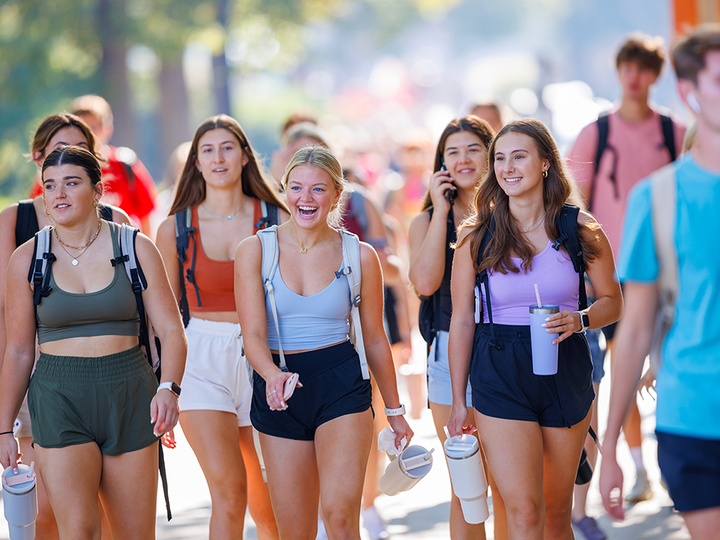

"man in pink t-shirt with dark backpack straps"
[567, 34, 685, 540]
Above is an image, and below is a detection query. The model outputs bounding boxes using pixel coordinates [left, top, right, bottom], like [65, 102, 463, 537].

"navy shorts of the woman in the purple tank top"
[470, 324, 595, 427]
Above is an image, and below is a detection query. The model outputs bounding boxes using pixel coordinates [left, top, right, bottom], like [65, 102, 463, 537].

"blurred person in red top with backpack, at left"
[70, 94, 157, 234]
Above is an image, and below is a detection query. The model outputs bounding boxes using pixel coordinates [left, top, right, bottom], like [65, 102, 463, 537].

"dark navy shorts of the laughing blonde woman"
[250, 341, 372, 441]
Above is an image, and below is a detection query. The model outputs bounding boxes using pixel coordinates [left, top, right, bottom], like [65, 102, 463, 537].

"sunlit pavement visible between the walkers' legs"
[0, 372, 690, 540]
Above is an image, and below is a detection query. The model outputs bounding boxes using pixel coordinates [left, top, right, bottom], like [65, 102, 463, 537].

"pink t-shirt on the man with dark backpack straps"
[567, 110, 685, 256]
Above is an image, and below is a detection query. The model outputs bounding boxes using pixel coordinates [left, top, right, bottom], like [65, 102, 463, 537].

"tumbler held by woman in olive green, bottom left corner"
[2, 463, 37, 540]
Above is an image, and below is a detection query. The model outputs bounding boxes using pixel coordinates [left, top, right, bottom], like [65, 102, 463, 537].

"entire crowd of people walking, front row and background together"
[0, 22, 720, 540]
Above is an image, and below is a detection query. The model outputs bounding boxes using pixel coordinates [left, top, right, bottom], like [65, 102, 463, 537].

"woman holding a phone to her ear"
[409, 115, 507, 540]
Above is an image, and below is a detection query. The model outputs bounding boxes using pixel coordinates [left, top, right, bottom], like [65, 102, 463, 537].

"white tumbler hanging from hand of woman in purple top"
[445, 435, 490, 524]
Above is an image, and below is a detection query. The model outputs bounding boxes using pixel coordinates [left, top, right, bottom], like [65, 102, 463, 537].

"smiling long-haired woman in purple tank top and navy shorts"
[448, 119, 622, 539]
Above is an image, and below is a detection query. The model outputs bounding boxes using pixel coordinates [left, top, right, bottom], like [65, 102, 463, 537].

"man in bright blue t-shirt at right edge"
[600, 24, 720, 540]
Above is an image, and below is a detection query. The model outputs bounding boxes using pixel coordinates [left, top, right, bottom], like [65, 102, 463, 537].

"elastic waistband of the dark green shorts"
[33, 346, 150, 384]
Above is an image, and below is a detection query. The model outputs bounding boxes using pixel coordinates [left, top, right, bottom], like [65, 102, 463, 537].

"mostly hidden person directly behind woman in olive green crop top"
[0, 113, 130, 540]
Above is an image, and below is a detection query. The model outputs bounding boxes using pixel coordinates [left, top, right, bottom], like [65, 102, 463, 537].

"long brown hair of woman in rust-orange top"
[170, 114, 288, 214]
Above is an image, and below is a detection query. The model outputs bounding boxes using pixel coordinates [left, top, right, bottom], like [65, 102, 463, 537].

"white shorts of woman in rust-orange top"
[179, 318, 252, 427]
